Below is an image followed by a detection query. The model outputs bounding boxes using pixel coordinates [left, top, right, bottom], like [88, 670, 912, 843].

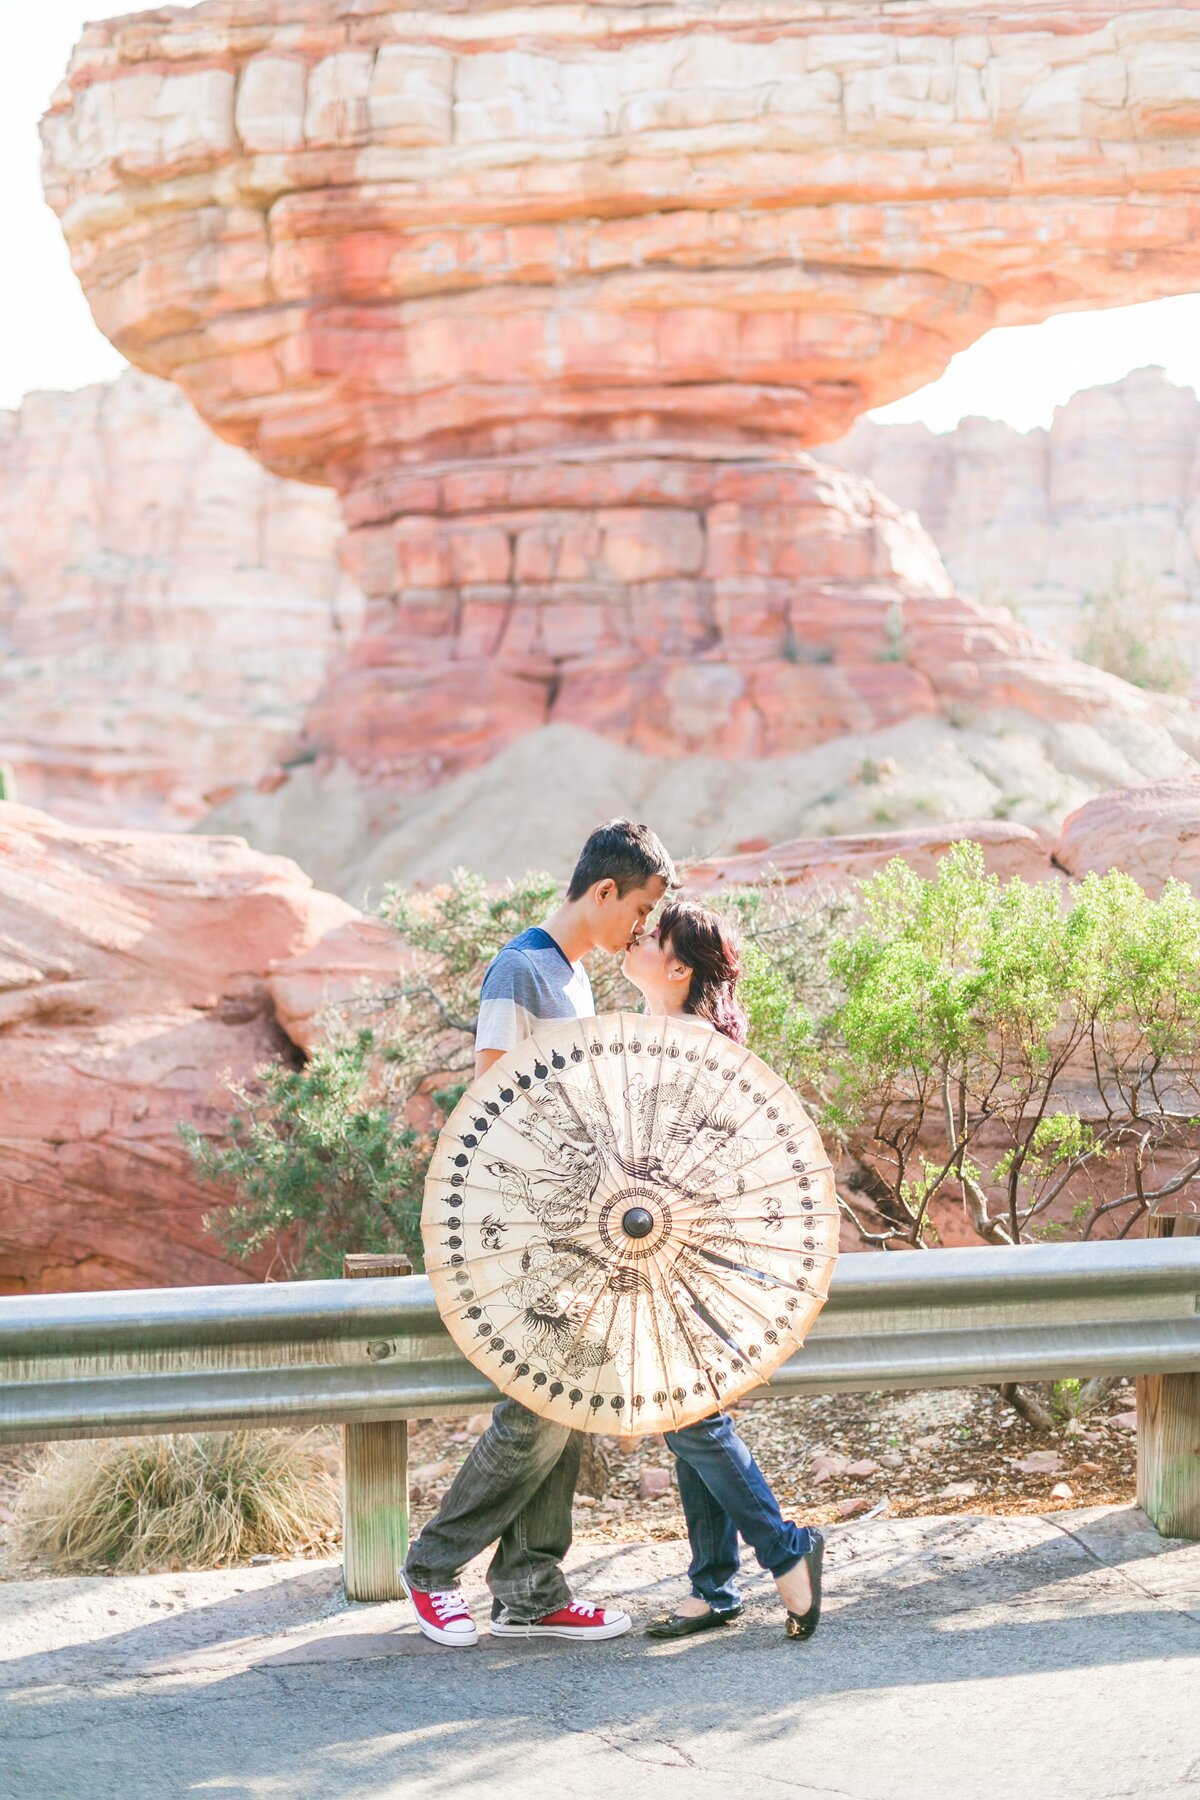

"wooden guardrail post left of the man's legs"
[342, 1256, 412, 1600]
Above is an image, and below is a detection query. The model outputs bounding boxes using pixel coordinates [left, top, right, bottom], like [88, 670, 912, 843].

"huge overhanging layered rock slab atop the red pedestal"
[45, 0, 1200, 488]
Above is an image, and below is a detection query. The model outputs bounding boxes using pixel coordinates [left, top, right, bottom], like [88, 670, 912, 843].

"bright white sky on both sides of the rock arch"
[0, 0, 1200, 432]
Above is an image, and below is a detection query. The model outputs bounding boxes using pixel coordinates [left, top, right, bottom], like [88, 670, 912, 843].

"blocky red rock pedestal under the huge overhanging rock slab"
[306, 454, 1187, 787]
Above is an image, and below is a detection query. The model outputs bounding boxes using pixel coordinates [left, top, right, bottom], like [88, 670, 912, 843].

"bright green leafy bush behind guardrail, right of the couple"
[817, 844, 1200, 1246]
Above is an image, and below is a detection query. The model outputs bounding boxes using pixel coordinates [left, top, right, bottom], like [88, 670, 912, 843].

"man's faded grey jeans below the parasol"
[405, 1400, 583, 1624]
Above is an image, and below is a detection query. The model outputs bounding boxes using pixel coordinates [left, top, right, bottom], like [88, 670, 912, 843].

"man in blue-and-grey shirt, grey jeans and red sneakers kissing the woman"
[405, 819, 678, 1645]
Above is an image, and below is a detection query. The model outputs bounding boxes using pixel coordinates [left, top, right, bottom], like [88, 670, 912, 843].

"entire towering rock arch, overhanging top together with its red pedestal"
[45, 0, 1200, 787]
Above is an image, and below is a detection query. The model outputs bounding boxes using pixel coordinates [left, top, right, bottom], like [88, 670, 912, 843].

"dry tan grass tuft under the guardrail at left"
[14, 1431, 342, 1573]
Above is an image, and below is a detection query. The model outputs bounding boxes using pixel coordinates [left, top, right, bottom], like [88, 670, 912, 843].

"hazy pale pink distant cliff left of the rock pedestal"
[0, 369, 362, 826]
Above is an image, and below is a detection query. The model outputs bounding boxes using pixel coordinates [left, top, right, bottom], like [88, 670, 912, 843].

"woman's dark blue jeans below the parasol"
[666, 1413, 813, 1613]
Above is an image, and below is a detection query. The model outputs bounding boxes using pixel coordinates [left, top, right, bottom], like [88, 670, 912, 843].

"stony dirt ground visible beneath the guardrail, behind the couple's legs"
[0, 1382, 1135, 1579]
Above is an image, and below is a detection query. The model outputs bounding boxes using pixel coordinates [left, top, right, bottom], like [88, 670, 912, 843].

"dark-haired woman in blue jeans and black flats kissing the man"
[624, 900, 824, 1638]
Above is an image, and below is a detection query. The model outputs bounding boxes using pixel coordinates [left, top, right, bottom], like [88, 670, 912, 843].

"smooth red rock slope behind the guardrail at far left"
[0, 805, 353, 1292]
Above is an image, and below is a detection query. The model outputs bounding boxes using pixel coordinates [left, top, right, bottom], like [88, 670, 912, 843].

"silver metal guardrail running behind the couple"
[0, 1237, 1200, 1444]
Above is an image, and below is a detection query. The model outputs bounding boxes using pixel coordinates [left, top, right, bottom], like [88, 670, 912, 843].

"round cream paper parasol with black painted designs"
[421, 1013, 838, 1435]
